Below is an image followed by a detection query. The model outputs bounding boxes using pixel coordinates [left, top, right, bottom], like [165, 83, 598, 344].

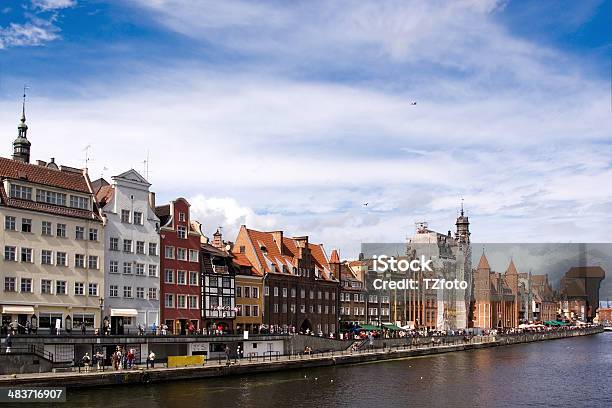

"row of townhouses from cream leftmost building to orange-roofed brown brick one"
[0, 110, 340, 335]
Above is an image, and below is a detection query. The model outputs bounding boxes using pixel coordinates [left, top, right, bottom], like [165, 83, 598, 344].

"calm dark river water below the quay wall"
[53, 333, 612, 408]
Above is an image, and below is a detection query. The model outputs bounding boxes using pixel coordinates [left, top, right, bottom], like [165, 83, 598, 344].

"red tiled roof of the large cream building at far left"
[0, 157, 90, 193]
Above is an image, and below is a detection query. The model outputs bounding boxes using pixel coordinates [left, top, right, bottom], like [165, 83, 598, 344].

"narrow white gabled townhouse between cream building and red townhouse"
[93, 170, 159, 334]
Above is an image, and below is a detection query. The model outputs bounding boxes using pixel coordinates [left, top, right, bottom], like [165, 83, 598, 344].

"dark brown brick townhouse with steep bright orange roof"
[233, 225, 339, 336]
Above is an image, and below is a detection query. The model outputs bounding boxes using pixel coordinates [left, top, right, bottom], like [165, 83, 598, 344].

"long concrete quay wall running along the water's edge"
[0, 328, 603, 388]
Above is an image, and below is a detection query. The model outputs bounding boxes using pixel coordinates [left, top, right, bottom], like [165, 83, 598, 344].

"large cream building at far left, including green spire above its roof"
[0, 109, 104, 333]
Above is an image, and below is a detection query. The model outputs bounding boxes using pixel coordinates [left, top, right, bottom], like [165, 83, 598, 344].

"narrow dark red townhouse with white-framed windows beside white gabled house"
[155, 198, 201, 334]
